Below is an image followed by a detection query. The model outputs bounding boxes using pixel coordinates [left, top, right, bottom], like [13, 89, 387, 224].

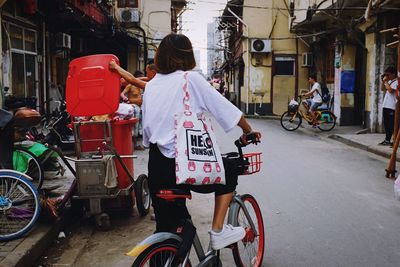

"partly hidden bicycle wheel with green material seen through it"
[13, 146, 44, 190]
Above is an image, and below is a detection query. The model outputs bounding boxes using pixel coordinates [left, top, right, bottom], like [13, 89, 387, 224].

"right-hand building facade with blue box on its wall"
[290, 0, 400, 132]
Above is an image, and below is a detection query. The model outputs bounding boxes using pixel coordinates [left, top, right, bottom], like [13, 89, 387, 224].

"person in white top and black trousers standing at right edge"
[379, 66, 397, 146]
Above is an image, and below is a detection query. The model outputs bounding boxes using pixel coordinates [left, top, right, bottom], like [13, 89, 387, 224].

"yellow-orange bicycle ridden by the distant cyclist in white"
[280, 96, 336, 132]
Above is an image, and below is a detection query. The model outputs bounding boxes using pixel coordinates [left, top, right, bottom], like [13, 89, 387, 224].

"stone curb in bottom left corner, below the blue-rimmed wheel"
[0, 218, 64, 267]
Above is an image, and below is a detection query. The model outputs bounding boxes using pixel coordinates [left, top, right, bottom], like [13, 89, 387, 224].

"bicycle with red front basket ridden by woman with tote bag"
[127, 137, 265, 267]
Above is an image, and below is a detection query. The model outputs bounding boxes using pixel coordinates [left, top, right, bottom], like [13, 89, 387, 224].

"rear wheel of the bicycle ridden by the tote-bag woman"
[132, 241, 192, 267]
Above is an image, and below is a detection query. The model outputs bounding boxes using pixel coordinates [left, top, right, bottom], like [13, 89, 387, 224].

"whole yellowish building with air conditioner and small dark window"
[219, 0, 309, 115]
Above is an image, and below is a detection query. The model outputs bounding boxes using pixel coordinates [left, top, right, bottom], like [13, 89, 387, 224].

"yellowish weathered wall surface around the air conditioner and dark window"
[241, 0, 309, 114]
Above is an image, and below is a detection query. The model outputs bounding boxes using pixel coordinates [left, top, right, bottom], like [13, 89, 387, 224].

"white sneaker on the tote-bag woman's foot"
[210, 224, 246, 250]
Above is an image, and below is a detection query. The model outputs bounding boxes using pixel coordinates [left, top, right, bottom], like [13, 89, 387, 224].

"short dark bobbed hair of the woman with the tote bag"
[154, 33, 196, 74]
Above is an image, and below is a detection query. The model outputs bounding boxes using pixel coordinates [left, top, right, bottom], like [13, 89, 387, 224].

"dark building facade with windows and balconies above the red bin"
[0, 0, 186, 113]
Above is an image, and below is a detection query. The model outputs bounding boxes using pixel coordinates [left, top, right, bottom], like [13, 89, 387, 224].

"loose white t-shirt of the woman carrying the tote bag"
[142, 71, 242, 158]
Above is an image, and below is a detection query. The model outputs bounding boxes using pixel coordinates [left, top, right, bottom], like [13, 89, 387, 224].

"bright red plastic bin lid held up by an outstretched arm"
[66, 54, 120, 116]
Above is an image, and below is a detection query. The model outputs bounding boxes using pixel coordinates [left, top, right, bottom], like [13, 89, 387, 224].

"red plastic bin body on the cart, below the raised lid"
[79, 118, 138, 189]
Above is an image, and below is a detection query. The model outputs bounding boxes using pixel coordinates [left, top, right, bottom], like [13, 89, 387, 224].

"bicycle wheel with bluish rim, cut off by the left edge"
[0, 170, 40, 241]
